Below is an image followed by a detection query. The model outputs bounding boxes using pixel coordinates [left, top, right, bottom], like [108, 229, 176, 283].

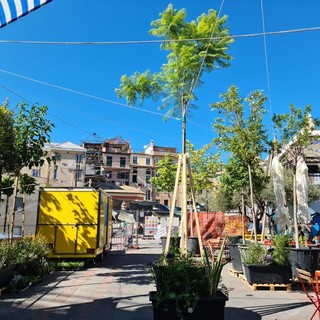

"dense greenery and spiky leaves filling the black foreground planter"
[151, 240, 227, 319]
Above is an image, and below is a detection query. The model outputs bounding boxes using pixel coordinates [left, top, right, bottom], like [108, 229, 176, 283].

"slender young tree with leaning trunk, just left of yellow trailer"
[9, 103, 56, 239]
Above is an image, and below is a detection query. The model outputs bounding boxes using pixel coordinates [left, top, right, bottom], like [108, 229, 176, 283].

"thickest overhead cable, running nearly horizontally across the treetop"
[0, 27, 320, 45]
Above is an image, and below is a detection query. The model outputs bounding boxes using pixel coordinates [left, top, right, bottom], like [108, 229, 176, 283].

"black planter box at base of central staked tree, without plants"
[149, 291, 228, 320]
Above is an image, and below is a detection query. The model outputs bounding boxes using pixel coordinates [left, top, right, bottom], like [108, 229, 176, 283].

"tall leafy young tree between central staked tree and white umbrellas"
[211, 85, 268, 240]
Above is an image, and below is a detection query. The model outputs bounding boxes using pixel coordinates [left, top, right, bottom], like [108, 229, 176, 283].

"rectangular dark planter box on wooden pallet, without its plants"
[243, 263, 292, 284]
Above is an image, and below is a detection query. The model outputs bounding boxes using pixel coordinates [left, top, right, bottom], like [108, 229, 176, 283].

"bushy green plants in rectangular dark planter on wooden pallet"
[242, 234, 292, 284]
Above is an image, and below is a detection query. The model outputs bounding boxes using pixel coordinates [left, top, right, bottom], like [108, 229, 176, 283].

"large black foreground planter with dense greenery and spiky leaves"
[150, 236, 228, 320]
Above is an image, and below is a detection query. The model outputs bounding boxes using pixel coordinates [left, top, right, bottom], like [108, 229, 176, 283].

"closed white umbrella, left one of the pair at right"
[271, 156, 292, 232]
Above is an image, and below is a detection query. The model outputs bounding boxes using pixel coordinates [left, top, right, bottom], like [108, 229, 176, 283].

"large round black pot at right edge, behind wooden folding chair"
[289, 248, 320, 277]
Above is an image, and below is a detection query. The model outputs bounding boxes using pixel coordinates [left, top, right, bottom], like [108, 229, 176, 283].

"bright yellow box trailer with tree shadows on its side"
[36, 188, 112, 259]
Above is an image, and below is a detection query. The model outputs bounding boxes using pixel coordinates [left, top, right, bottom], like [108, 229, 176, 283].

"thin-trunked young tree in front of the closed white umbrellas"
[272, 104, 320, 248]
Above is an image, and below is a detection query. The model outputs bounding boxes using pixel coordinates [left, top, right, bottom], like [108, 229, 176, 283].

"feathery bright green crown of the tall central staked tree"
[115, 4, 233, 120]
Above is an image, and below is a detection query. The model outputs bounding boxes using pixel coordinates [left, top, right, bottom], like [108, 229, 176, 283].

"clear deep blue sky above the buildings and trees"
[0, 0, 320, 152]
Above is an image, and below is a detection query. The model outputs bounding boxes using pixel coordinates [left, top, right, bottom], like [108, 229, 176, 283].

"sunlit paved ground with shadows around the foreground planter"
[0, 239, 315, 320]
